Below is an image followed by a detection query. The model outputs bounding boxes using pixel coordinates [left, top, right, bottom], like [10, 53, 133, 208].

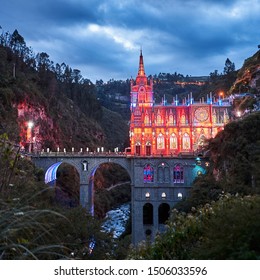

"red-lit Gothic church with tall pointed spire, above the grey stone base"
[129, 51, 230, 156]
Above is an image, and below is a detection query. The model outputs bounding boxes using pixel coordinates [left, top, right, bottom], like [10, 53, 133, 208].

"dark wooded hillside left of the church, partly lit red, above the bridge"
[0, 45, 128, 151]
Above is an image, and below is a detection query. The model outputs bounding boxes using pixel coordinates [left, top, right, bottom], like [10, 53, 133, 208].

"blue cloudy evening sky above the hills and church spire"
[0, 0, 260, 83]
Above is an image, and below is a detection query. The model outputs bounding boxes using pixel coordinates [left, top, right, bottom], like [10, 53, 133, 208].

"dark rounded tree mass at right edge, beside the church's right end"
[209, 112, 260, 194]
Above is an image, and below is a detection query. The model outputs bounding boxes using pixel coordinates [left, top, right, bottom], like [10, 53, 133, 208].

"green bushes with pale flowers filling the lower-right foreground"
[128, 195, 260, 260]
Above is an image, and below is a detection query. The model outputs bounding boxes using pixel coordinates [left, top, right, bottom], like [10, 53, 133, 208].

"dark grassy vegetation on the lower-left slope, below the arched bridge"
[0, 135, 133, 259]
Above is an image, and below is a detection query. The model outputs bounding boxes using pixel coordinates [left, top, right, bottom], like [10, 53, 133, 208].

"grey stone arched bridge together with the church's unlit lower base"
[32, 153, 208, 244]
